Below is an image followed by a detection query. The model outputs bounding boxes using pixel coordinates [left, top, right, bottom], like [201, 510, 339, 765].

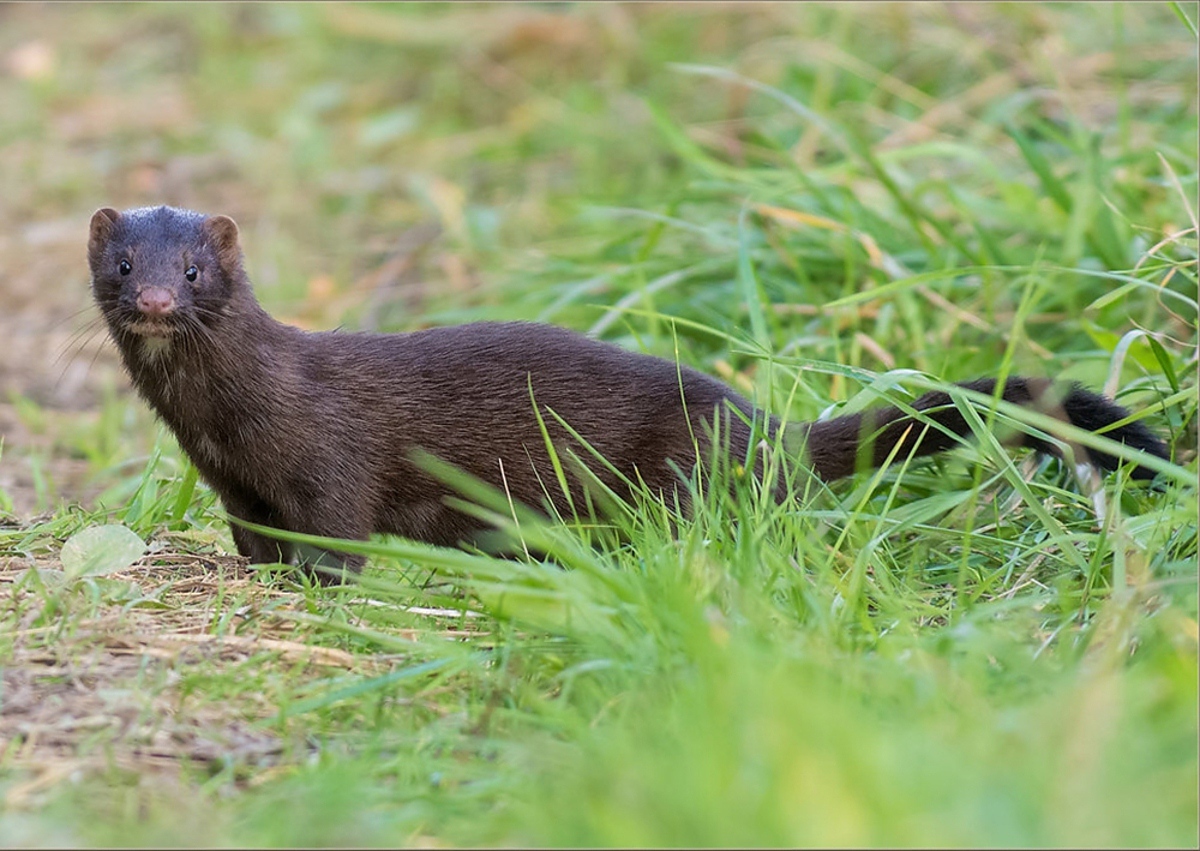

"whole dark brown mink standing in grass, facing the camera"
[88, 206, 1168, 574]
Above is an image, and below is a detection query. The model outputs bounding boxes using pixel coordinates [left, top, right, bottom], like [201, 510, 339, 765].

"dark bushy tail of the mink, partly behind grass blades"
[797, 376, 1170, 481]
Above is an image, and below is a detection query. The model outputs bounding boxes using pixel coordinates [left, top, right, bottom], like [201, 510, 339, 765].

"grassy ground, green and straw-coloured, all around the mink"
[0, 4, 1200, 846]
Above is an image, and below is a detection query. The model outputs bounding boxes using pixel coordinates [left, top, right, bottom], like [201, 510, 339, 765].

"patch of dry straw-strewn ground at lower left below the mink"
[0, 541, 494, 809]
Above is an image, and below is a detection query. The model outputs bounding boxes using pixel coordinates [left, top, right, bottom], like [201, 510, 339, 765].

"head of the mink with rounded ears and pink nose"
[88, 206, 248, 338]
